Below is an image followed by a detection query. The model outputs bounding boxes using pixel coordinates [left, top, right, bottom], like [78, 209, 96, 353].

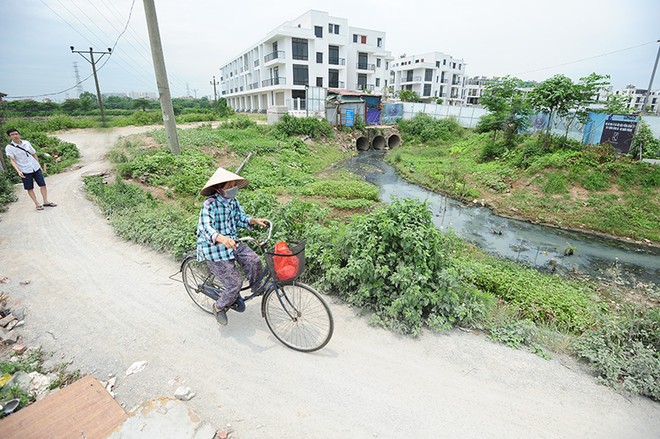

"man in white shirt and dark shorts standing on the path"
[5, 128, 57, 210]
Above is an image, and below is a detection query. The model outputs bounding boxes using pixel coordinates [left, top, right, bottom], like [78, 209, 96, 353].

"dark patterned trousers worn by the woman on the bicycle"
[206, 242, 263, 308]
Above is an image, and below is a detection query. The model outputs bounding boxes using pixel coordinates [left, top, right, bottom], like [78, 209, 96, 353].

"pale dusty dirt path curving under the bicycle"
[0, 128, 660, 438]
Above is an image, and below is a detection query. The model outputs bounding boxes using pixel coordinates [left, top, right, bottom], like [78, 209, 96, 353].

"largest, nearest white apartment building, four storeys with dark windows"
[219, 10, 393, 112]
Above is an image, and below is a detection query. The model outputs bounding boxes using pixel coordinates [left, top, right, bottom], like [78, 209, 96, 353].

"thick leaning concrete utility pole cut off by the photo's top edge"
[143, 0, 181, 155]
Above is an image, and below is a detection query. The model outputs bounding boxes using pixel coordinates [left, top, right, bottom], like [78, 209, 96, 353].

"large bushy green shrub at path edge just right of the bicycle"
[309, 199, 494, 334]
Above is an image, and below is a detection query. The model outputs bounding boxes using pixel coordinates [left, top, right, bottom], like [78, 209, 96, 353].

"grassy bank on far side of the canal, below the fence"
[387, 119, 660, 244]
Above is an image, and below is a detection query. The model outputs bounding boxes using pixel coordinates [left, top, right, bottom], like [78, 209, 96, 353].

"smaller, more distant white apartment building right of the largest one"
[390, 52, 465, 105]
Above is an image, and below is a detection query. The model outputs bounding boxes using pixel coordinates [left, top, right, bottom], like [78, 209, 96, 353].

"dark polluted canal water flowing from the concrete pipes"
[338, 151, 660, 285]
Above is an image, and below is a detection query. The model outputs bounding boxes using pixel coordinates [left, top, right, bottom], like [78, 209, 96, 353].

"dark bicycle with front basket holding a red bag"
[180, 221, 334, 352]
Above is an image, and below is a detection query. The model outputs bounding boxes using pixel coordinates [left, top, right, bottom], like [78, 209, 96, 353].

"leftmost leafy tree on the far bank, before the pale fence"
[477, 76, 531, 146]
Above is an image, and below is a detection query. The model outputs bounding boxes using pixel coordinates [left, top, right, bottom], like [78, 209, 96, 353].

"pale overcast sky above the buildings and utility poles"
[0, 0, 660, 101]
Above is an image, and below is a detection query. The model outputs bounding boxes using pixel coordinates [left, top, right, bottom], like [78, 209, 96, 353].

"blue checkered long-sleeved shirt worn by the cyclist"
[197, 194, 252, 261]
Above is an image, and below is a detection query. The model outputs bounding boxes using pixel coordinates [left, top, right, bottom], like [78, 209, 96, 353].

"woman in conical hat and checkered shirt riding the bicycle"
[197, 168, 267, 326]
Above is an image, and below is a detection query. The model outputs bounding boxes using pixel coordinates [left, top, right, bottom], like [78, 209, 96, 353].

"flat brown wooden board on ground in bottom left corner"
[0, 375, 127, 439]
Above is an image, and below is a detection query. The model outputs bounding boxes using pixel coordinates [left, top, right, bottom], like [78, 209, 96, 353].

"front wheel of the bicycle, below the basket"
[262, 283, 334, 352]
